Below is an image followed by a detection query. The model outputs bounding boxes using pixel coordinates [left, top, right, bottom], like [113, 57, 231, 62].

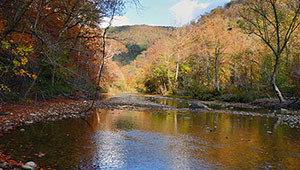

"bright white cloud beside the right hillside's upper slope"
[170, 0, 210, 25]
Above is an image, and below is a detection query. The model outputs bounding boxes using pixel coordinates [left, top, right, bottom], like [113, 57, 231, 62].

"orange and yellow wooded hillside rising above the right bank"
[109, 0, 300, 102]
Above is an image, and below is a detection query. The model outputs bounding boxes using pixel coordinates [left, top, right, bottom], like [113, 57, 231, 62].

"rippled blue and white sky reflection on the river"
[82, 130, 217, 169]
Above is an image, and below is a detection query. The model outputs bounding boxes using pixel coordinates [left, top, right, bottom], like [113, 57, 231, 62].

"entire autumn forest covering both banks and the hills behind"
[0, 0, 300, 102]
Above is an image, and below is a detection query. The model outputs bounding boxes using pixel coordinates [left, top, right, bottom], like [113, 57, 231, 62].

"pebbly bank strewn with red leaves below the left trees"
[0, 99, 92, 170]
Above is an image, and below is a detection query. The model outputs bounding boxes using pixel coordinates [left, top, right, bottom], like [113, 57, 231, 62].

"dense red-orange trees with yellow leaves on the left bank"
[0, 0, 138, 100]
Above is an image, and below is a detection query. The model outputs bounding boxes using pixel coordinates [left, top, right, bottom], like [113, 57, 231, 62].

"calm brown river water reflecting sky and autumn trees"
[0, 95, 300, 170]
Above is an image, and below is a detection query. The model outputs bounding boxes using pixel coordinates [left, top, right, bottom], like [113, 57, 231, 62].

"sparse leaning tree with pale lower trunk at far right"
[240, 0, 300, 102]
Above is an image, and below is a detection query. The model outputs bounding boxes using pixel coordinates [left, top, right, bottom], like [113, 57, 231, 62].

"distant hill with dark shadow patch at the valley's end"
[108, 25, 175, 66]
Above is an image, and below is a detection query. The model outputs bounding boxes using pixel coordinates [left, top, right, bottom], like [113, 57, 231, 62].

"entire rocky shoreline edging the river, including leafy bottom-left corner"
[0, 95, 300, 169]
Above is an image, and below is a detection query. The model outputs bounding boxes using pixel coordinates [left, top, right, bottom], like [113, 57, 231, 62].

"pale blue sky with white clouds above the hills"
[104, 0, 230, 26]
